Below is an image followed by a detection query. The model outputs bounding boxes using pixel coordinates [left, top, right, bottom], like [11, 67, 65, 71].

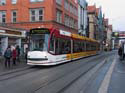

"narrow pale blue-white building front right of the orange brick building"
[78, 0, 88, 36]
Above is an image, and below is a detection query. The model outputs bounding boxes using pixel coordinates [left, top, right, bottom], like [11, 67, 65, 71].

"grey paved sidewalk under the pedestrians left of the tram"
[0, 56, 28, 73]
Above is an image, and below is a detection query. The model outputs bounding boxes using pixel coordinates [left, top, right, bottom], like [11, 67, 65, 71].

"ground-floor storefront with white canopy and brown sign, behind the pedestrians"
[0, 27, 26, 55]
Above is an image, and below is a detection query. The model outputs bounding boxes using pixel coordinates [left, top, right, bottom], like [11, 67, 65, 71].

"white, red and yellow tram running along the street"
[27, 28, 100, 66]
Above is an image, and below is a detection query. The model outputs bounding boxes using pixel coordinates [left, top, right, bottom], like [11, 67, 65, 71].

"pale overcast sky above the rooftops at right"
[87, 0, 125, 31]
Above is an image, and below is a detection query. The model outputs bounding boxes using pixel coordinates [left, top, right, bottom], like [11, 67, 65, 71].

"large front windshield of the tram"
[30, 34, 49, 51]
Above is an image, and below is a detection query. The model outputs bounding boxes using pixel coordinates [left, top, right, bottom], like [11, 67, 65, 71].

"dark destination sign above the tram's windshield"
[30, 28, 50, 34]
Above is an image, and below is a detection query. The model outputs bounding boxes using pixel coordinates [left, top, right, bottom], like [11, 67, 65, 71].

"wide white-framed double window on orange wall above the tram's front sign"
[30, 8, 43, 22]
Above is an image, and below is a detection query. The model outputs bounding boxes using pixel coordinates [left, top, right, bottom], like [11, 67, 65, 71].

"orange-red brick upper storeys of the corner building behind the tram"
[0, 0, 78, 33]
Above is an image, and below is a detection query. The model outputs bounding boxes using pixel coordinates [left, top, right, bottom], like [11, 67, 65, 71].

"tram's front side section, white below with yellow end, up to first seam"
[48, 37, 71, 65]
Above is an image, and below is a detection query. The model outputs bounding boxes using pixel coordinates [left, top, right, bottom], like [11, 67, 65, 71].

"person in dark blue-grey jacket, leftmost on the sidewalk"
[4, 46, 12, 68]
